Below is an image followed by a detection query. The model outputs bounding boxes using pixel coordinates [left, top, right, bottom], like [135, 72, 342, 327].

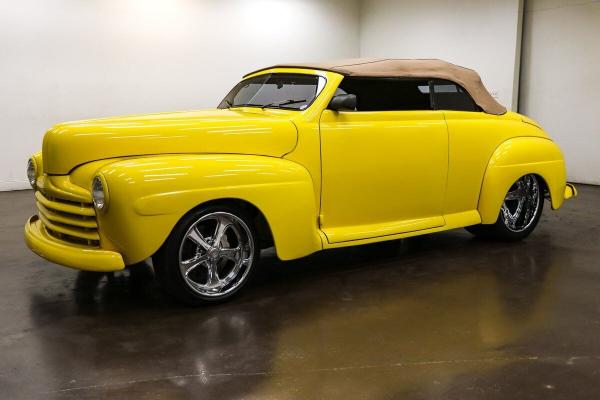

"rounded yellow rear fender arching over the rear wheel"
[478, 137, 566, 224]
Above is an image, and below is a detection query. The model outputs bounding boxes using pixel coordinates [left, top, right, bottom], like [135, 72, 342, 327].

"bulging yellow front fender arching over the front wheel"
[98, 154, 322, 264]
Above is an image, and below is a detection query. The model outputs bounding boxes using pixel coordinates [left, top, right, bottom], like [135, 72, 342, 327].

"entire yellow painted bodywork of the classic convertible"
[25, 68, 576, 270]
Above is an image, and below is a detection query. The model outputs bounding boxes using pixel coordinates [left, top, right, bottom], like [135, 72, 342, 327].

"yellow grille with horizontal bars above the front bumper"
[35, 191, 100, 247]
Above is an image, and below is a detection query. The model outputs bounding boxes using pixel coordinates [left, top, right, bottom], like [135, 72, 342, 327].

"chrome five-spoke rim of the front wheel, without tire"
[179, 212, 254, 297]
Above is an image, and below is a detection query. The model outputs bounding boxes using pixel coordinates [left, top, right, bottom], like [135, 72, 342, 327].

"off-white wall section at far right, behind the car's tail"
[521, 0, 600, 184]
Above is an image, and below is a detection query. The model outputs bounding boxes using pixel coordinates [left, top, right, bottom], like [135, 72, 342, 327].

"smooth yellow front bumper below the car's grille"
[25, 215, 125, 272]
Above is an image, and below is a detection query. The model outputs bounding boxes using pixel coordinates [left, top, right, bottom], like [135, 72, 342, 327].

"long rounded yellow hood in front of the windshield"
[43, 108, 297, 175]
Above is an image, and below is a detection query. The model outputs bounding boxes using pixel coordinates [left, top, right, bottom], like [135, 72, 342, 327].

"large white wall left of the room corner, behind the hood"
[0, 0, 359, 190]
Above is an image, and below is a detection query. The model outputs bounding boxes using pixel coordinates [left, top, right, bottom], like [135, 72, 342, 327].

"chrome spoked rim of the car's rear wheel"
[500, 175, 543, 232]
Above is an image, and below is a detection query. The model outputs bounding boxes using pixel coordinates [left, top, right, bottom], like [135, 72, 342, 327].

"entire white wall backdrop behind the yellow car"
[0, 0, 600, 190]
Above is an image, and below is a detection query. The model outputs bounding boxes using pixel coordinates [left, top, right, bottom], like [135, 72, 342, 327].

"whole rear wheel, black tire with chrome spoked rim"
[466, 174, 544, 240]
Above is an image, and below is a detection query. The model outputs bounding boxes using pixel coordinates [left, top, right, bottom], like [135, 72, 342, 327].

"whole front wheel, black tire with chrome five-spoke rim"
[153, 206, 259, 305]
